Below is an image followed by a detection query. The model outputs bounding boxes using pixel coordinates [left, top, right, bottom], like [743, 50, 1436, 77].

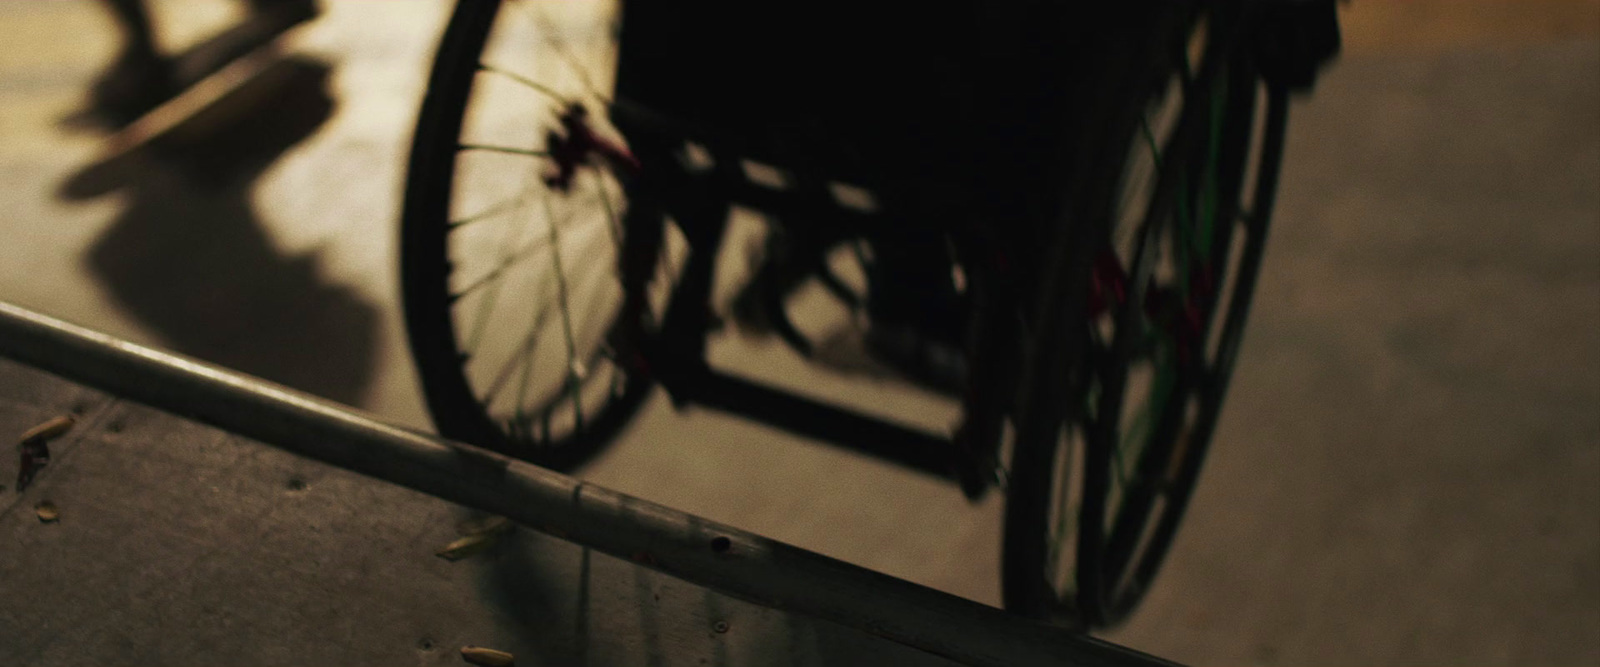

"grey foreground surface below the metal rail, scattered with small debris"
[0, 360, 954, 665]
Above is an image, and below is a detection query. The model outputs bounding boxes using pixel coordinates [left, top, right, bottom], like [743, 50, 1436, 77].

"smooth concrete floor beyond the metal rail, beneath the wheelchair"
[0, 0, 1600, 664]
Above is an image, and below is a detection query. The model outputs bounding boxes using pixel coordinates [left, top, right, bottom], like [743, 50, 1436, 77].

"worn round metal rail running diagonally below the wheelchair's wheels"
[0, 302, 1170, 667]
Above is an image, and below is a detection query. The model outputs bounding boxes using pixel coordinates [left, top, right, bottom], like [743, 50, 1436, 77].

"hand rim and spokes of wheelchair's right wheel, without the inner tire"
[1045, 12, 1282, 625]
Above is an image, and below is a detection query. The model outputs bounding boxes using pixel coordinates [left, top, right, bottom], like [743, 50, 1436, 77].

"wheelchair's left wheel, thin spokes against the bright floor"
[403, 2, 670, 467]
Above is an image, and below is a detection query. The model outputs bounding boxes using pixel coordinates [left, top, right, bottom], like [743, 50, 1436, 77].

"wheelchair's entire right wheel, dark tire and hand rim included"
[1002, 7, 1286, 629]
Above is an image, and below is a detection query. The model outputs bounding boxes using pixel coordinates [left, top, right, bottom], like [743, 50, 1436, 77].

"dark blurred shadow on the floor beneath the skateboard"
[59, 58, 378, 403]
